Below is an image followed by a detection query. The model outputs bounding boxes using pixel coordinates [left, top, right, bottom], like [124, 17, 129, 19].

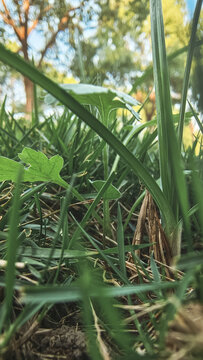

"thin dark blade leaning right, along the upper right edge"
[178, 0, 202, 143]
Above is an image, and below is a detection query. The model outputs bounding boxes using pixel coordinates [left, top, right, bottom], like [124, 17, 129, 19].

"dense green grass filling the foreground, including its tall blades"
[0, 0, 203, 360]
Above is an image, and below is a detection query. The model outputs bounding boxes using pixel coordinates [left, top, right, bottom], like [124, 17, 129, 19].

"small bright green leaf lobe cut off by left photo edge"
[0, 156, 23, 182]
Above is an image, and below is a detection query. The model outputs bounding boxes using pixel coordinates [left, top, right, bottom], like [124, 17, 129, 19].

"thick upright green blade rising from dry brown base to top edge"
[150, 0, 191, 255]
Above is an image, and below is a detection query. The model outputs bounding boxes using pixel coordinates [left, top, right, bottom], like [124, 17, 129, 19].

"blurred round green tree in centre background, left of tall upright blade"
[71, 0, 149, 86]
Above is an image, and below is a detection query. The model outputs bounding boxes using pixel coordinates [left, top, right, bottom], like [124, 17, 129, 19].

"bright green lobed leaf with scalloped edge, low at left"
[18, 148, 64, 184]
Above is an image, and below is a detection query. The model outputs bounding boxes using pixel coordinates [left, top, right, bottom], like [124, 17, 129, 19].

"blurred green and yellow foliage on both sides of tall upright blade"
[71, 0, 189, 120]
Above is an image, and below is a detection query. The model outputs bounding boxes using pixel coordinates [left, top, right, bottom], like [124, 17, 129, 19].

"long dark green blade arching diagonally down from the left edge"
[0, 44, 175, 232]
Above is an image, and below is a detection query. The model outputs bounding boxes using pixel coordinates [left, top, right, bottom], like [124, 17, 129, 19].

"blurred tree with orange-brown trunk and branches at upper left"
[0, 0, 85, 113]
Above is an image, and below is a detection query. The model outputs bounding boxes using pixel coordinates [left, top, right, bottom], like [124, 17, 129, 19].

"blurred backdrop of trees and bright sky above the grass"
[0, 0, 201, 116]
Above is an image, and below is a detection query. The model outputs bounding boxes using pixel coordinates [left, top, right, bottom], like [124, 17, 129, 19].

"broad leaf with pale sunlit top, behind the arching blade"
[45, 84, 140, 121]
